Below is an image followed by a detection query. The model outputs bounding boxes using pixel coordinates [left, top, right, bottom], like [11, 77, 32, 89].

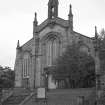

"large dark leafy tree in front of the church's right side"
[53, 44, 95, 88]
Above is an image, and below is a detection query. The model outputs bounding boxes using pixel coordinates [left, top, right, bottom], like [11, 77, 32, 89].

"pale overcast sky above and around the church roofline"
[0, 0, 105, 68]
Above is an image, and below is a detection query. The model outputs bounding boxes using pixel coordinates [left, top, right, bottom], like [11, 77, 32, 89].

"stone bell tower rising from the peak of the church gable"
[48, 0, 59, 19]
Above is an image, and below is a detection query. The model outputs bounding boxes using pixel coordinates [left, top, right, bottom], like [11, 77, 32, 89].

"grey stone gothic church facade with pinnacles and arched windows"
[14, 0, 97, 89]
